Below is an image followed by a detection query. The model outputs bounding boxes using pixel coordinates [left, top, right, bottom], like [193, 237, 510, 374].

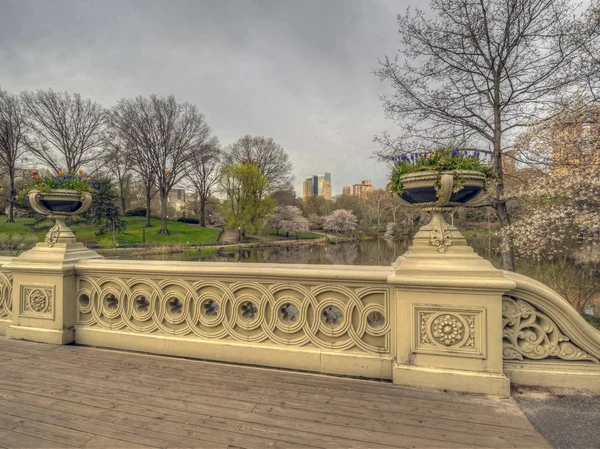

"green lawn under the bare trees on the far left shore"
[0, 216, 220, 246]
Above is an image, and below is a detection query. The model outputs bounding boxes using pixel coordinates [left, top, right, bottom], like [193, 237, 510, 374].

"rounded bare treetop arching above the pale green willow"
[225, 136, 293, 193]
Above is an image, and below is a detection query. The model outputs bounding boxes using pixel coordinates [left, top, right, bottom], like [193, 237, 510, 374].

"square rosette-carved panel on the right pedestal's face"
[412, 304, 486, 358]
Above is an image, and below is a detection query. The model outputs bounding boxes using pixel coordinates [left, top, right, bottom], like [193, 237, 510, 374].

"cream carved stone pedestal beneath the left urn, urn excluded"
[2, 242, 101, 344]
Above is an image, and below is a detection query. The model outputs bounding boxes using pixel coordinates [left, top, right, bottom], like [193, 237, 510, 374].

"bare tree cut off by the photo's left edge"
[0, 89, 25, 223]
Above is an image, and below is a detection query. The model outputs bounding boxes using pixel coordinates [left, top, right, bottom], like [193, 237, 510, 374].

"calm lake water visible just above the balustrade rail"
[130, 233, 502, 268]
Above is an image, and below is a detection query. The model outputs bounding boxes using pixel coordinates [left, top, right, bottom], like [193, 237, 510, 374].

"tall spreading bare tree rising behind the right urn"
[375, 0, 597, 270]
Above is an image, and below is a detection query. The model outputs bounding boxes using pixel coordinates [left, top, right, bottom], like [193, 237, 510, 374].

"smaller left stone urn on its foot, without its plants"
[29, 189, 92, 248]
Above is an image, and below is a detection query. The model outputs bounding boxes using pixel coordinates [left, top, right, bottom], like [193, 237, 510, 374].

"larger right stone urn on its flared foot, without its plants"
[400, 170, 487, 253]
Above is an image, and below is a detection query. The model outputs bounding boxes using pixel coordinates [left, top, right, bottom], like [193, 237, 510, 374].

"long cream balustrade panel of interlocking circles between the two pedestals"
[77, 275, 391, 354]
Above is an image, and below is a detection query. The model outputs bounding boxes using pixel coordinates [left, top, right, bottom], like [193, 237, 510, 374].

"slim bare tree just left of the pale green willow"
[186, 137, 221, 227]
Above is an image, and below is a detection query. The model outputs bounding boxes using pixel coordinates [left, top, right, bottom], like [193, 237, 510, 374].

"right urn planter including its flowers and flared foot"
[389, 148, 493, 253]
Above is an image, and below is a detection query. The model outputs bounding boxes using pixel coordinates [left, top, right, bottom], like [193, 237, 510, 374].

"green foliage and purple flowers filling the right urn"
[389, 146, 497, 195]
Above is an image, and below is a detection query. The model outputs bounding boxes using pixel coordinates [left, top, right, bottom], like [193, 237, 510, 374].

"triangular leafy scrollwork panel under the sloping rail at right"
[502, 296, 600, 364]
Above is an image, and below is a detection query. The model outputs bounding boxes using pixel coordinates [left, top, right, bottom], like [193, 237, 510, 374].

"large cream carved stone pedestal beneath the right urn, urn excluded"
[388, 217, 515, 396]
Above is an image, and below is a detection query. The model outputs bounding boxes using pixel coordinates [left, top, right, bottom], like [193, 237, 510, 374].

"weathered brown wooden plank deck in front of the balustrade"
[0, 337, 549, 449]
